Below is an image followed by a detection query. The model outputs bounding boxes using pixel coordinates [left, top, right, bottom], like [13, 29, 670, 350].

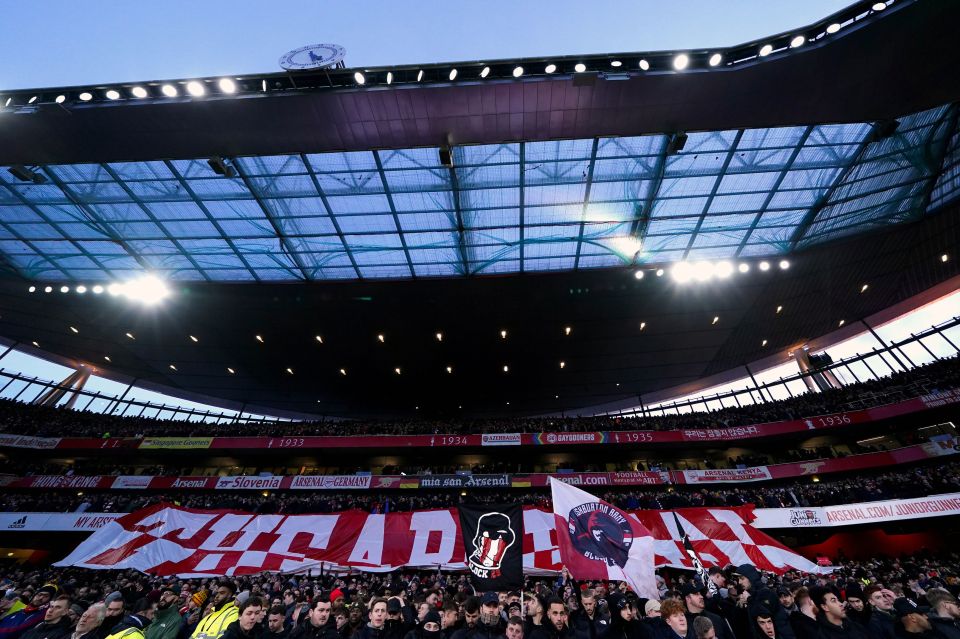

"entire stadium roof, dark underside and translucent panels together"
[0, 0, 960, 415]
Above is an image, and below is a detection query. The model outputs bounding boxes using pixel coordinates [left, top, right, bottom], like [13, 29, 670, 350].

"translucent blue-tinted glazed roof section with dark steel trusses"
[0, 101, 960, 281]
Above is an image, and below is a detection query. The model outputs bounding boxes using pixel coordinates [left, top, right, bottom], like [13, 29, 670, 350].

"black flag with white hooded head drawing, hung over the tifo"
[459, 505, 523, 591]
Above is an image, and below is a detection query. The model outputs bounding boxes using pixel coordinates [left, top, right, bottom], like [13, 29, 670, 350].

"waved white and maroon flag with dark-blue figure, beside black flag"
[550, 477, 659, 599]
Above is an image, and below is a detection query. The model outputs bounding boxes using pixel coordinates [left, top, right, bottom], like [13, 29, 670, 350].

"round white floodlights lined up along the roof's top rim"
[3, 2, 888, 107]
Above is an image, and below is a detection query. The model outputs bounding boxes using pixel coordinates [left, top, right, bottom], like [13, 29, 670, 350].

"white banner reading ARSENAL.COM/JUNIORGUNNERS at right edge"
[753, 493, 960, 528]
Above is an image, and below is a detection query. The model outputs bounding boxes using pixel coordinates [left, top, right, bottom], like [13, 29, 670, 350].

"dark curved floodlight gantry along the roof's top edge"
[0, 0, 895, 109]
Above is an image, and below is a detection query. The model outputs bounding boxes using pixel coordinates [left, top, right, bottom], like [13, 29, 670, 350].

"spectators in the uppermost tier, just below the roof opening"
[0, 357, 960, 438]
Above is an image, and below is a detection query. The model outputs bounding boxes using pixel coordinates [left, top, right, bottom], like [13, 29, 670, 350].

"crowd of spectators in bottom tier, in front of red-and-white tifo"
[0, 554, 960, 639]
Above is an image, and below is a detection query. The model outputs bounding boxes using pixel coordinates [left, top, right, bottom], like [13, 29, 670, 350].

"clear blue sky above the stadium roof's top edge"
[0, 0, 849, 90]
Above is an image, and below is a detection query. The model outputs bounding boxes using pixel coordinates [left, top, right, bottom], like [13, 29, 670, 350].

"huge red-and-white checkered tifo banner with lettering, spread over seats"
[57, 505, 823, 577]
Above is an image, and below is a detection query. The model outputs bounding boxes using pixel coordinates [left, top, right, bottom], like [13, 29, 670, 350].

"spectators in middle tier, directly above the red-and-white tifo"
[0, 462, 960, 514]
